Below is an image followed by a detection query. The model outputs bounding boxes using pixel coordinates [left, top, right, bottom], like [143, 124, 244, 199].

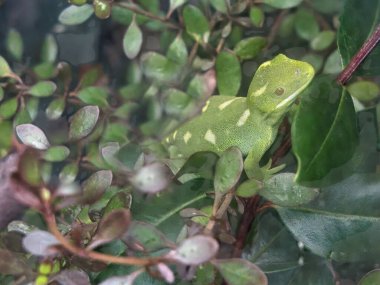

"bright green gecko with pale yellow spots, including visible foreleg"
[163, 54, 314, 180]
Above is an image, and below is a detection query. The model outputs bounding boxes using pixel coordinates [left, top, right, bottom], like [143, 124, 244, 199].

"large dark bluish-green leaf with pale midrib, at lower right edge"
[276, 172, 380, 262]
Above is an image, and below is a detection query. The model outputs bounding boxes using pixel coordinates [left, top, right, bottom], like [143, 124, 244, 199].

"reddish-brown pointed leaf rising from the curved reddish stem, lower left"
[87, 209, 131, 249]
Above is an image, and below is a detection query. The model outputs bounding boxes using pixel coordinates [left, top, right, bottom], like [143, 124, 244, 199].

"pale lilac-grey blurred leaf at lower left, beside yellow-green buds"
[22, 230, 60, 256]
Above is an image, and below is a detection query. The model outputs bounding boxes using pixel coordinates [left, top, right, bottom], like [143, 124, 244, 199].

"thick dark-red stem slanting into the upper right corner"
[336, 25, 380, 85]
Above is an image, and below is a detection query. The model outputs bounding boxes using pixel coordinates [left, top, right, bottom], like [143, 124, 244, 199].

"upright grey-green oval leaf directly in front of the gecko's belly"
[214, 147, 243, 193]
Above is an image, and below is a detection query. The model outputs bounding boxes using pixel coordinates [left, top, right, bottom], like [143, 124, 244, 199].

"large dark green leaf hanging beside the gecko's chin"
[292, 76, 358, 185]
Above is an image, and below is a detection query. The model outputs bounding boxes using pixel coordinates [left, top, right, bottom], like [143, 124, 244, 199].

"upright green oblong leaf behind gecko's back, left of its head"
[215, 51, 241, 96]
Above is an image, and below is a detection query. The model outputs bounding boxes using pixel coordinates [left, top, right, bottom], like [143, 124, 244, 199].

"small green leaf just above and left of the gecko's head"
[234, 37, 267, 60]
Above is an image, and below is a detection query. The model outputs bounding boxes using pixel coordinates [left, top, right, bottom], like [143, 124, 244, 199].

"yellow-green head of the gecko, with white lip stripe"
[248, 54, 314, 113]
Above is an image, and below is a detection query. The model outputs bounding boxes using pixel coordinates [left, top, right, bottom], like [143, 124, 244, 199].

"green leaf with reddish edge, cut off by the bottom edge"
[212, 258, 268, 285]
